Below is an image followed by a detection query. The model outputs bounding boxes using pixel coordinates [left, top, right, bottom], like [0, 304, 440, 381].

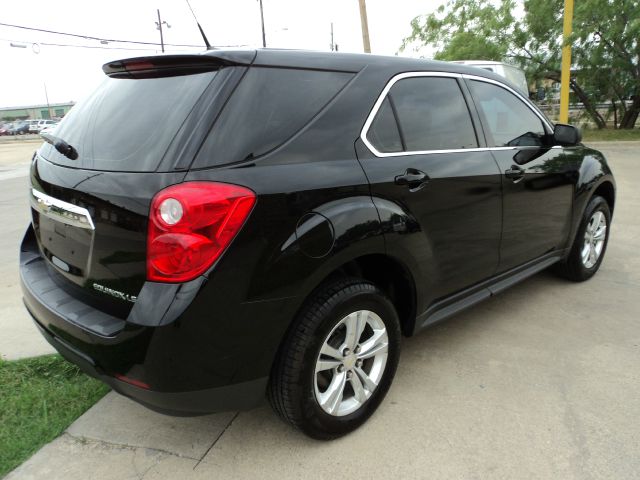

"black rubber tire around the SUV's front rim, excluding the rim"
[556, 195, 611, 282]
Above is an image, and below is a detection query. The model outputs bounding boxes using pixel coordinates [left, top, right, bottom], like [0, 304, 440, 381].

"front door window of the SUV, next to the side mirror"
[469, 80, 545, 147]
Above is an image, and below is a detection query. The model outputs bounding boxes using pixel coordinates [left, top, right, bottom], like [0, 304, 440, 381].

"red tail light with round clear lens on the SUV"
[147, 182, 256, 283]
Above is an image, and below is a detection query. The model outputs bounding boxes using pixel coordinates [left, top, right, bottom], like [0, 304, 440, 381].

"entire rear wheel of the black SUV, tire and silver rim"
[268, 278, 400, 439]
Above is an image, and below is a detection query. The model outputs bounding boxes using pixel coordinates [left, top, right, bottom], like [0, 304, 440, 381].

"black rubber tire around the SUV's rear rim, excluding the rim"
[267, 279, 401, 440]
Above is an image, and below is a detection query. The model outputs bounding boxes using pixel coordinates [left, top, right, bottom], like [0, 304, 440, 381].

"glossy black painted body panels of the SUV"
[21, 50, 614, 413]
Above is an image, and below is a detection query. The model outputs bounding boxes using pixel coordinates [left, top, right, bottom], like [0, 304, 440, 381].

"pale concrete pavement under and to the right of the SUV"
[3, 142, 640, 480]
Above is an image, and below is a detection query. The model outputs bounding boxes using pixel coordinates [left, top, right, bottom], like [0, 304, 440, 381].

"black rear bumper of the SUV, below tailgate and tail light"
[20, 227, 291, 415]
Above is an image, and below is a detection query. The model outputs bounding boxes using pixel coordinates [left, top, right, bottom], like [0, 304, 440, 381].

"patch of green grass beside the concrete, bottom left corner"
[0, 355, 109, 478]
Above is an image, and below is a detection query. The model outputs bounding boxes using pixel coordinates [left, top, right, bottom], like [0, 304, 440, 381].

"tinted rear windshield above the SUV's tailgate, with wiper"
[40, 72, 216, 172]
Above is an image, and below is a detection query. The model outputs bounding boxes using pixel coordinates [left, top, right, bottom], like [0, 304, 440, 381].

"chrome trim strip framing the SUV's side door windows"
[360, 72, 556, 158]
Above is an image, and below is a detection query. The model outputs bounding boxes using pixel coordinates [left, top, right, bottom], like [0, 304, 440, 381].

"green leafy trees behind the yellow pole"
[401, 0, 640, 128]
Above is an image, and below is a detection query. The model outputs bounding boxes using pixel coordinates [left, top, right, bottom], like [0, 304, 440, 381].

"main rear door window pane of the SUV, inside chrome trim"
[380, 77, 478, 151]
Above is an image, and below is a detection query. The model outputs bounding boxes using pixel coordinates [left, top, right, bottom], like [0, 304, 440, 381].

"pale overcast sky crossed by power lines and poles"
[0, 0, 444, 107]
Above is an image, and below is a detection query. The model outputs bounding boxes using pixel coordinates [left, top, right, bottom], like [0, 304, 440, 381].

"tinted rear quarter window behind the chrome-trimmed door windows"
[192, 67, 353, 168]
